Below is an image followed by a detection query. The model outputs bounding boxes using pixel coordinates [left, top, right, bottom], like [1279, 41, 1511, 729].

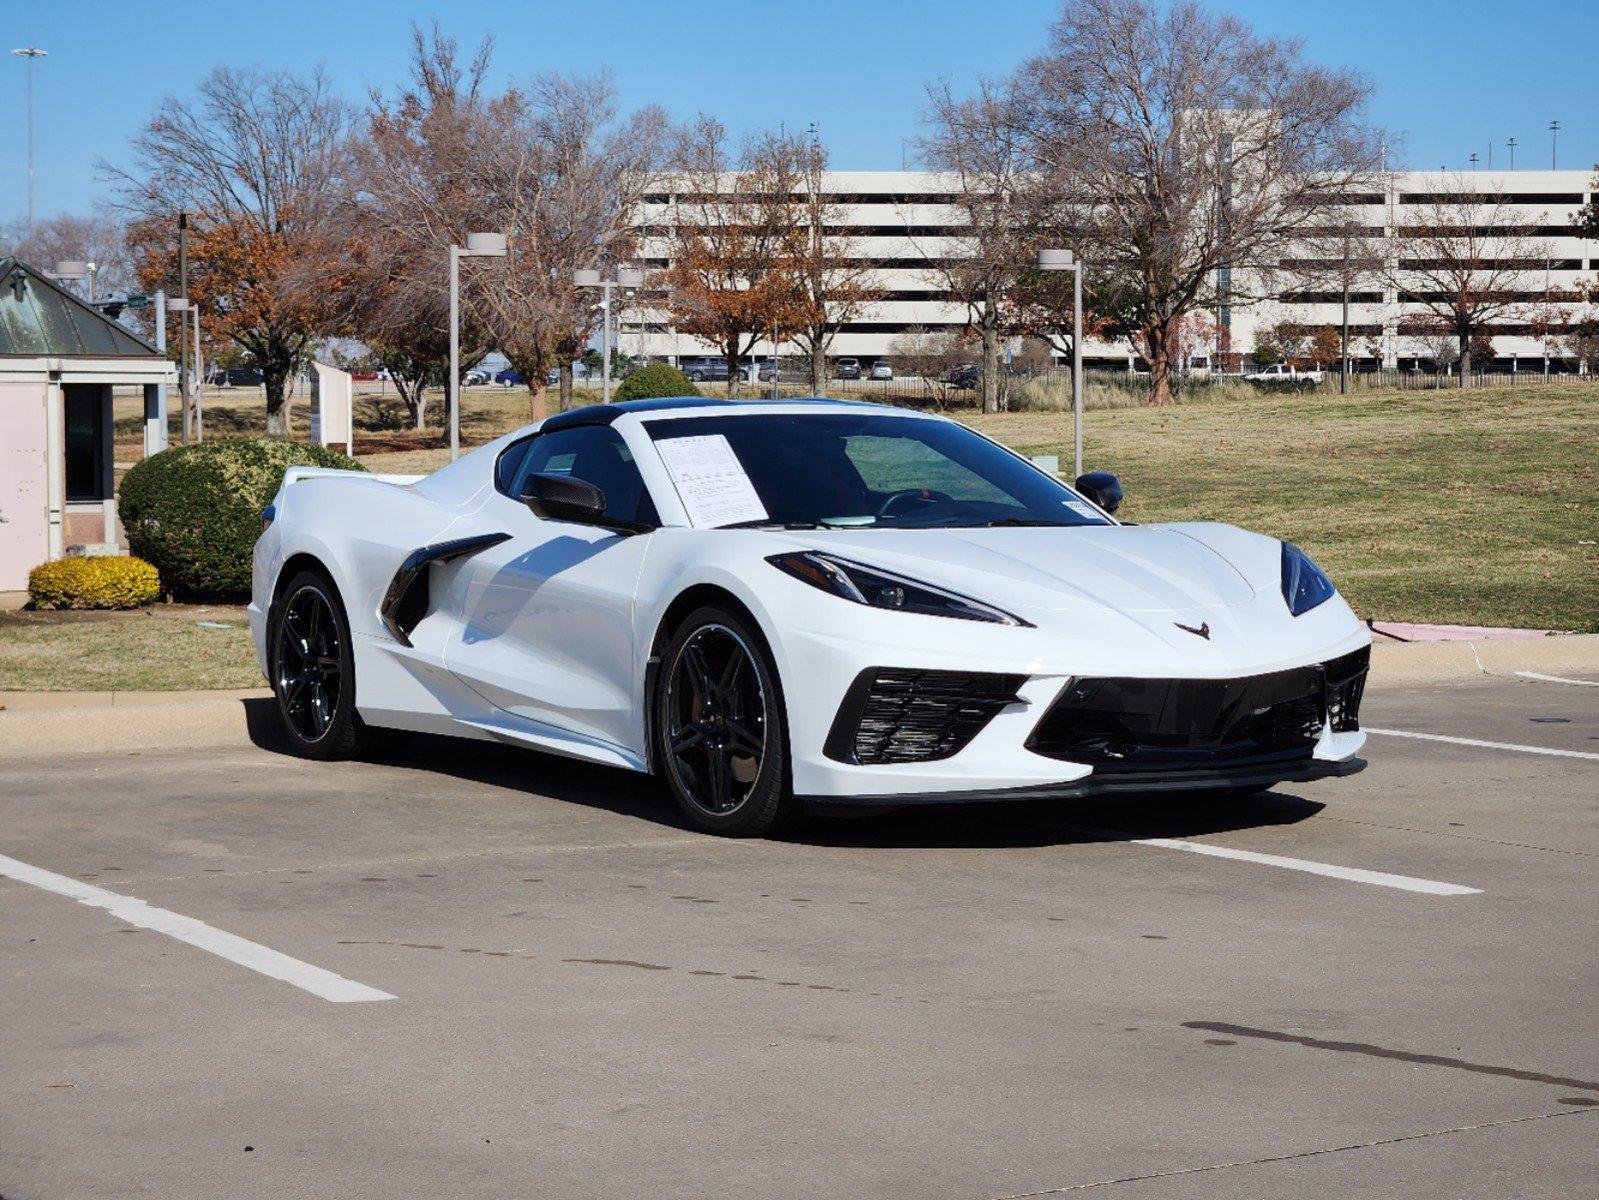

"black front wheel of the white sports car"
[654, 606, 800, 837]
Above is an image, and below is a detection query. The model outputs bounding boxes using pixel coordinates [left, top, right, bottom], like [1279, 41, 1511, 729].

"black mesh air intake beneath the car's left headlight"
[822, 667, 1027, 765]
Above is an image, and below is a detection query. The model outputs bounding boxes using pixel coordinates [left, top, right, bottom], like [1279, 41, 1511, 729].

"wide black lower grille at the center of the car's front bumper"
[1027, 648, 1370, 773]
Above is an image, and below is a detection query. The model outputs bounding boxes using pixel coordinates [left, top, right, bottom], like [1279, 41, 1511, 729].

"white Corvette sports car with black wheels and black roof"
[249, 398, 1370, 834]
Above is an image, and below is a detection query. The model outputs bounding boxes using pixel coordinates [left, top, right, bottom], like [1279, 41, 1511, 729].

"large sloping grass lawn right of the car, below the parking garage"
[966, 386, 1599, 634]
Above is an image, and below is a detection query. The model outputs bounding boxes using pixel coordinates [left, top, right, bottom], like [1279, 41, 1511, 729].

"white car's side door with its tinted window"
[445, 426, 657, 752]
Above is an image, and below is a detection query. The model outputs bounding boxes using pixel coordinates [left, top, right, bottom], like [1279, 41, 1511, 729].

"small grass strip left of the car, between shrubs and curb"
[0, 605, 265, 691]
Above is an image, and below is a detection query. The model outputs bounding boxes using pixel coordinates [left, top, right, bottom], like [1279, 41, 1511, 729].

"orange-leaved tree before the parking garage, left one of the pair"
[657, 115, 814, 395]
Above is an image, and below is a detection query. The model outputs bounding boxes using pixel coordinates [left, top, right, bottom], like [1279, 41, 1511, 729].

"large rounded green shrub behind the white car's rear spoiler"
[117, 438, 365, 600]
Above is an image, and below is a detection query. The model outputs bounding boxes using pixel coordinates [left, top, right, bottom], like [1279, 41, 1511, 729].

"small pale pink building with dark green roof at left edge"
[0, 258, 177, 592]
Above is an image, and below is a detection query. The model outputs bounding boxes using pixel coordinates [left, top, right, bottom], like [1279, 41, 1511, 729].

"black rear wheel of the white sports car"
[267, 571, 371, 758]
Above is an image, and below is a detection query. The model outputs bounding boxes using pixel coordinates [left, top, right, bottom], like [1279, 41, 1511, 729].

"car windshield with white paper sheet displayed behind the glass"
[644, 413, 1111, 530]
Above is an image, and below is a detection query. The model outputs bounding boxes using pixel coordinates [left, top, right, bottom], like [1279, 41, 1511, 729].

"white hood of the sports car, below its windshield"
[767, 525, 1276, 618]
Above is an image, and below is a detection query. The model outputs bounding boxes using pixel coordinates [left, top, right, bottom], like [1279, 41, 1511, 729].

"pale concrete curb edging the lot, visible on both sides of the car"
[0, 634, 1599, 762]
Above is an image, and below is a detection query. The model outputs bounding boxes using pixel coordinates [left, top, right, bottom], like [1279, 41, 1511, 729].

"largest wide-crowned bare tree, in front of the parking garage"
[1012, 0, 1382, 405]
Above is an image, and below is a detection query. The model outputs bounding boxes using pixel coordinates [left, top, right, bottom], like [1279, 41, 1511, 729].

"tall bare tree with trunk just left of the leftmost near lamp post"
[341, 24, 497, 429]
